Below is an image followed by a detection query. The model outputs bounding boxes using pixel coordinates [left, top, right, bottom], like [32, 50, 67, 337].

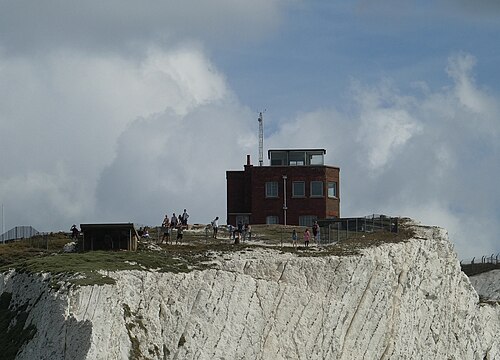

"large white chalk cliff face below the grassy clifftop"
[0, 226, 500, 360]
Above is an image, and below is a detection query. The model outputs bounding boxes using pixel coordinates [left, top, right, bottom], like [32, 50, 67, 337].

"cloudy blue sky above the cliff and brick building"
[0, 0, 500, 259]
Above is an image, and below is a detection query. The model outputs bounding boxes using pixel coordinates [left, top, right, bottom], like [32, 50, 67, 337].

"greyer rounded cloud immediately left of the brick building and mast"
[96, 102, 257, 224]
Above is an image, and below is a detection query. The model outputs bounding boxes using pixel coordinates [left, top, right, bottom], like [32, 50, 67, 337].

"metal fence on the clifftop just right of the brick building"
[318, 214, 399, 244]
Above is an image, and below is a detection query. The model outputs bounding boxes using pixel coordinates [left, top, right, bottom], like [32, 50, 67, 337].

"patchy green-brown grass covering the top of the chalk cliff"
[0, 221, 413, 288]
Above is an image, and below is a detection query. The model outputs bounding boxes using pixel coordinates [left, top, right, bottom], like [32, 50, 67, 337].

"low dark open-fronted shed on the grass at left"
[79, 223, 139, 251]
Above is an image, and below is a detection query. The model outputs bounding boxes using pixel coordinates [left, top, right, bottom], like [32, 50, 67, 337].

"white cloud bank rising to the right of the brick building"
[267, 54, 500, 258]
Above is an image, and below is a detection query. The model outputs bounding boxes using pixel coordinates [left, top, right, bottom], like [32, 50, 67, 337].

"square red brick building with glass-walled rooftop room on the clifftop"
[226, 149, 340, 226]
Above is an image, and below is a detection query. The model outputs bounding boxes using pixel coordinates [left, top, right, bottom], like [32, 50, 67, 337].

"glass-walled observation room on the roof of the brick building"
[267, 149, 326, 166]
